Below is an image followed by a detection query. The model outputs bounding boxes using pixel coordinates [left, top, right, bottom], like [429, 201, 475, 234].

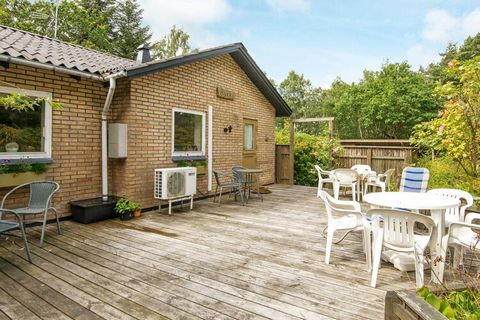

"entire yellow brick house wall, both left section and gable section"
[0, 55, 275, 215]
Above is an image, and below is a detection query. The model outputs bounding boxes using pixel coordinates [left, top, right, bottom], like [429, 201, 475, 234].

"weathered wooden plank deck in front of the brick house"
[0, 185, 446, 320]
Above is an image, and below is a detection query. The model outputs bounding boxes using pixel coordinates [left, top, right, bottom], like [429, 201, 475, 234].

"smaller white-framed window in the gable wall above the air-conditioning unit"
[172, 108, 205, 156]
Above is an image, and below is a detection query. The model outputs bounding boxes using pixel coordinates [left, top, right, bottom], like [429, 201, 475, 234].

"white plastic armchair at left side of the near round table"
[319, 190, 372, 271]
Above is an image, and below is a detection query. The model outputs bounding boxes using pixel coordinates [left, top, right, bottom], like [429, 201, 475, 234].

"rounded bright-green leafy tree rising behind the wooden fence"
[357, 62, 440, 139]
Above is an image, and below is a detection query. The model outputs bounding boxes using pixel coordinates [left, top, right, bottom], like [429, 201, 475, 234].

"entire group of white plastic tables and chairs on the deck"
[316, 166, 480, 287]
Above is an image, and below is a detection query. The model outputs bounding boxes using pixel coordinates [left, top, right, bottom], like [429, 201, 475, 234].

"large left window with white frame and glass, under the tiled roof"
[0, 87, 52, 159]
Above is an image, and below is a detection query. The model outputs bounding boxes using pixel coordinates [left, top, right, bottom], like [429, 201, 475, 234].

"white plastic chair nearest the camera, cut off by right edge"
[438, 212, 480, 281]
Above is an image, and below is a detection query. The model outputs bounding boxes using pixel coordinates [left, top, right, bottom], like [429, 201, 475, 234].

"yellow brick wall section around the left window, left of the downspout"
[0, 64, 107, 215]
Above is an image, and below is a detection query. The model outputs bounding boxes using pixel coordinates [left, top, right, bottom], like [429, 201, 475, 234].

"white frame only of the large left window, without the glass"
[0, 87, 52, 160]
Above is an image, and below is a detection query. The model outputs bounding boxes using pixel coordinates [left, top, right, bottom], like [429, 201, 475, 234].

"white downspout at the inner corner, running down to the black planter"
[102, 71, 125, 201]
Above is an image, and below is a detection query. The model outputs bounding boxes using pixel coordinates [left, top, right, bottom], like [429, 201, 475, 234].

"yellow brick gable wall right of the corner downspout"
[108, 55, 275, 207]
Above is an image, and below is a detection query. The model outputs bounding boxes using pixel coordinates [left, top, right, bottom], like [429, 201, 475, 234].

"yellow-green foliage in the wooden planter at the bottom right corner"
[417, 287, 480, 320]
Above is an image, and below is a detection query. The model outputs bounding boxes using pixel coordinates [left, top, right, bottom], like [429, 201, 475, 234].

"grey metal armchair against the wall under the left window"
[0, 181, 62, 247]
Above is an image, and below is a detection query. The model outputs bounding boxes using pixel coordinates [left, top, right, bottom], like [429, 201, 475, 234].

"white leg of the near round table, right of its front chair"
[430, 209, 445, 283]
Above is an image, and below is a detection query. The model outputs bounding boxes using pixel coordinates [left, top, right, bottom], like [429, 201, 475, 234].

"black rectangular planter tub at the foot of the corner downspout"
[70, 197, 117, 223]
